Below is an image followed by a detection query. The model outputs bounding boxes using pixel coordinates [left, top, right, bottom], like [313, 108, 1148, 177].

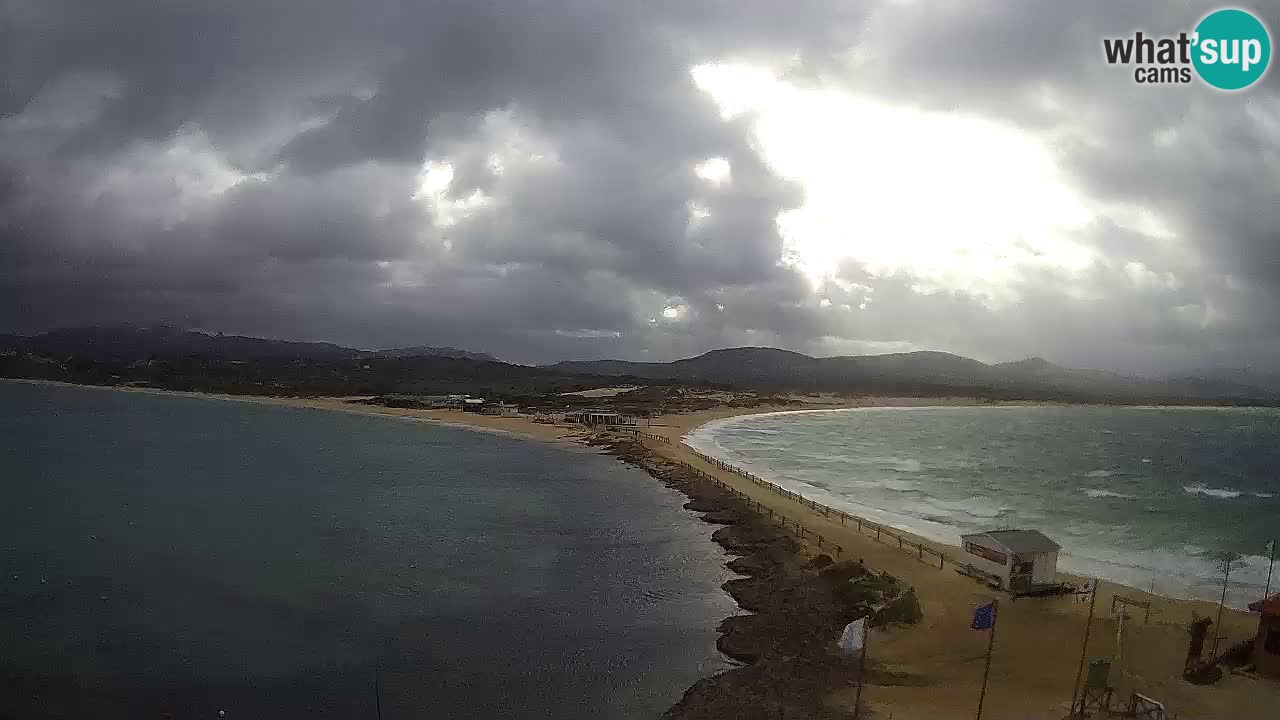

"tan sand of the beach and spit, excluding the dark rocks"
[12, 379, 1280, 720]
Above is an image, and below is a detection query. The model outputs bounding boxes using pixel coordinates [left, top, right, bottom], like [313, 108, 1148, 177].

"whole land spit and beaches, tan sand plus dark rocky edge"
[10, 379, 1280, 720]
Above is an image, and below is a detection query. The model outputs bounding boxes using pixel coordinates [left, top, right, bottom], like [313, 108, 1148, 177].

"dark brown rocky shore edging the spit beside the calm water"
[593, 438, 919, 720]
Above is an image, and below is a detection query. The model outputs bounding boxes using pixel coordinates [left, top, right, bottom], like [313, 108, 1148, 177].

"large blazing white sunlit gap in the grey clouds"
[692, 64, 1097, 299]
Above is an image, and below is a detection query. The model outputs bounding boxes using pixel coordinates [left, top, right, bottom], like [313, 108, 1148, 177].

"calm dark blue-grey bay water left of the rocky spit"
[0, 383, 733, 719]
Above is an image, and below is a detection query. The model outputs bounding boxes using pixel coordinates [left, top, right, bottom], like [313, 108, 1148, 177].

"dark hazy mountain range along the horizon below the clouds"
[0, 325, 1280, 402]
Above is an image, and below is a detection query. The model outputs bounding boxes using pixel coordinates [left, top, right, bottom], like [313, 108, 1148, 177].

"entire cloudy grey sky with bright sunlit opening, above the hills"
[0, 0, 1280, 374]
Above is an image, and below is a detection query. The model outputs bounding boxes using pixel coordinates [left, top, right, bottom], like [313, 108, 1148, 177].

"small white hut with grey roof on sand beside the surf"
[960, 530, 1062, 594]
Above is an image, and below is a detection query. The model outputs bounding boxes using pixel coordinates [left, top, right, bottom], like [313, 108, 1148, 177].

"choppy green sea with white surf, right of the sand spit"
[686, 406, 1280, 607]
